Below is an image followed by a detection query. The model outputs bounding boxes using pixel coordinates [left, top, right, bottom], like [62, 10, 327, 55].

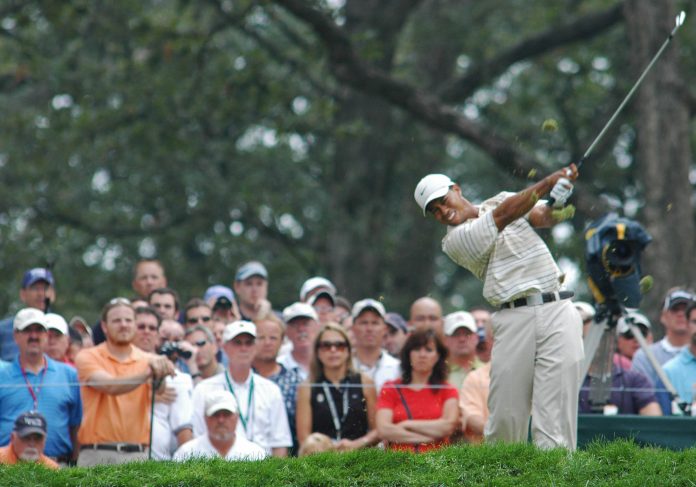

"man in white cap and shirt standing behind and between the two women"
[351, 299, 401, 395]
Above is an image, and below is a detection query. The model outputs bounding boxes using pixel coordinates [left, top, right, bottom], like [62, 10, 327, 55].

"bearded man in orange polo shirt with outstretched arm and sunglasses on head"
[75, 298, 174, 467]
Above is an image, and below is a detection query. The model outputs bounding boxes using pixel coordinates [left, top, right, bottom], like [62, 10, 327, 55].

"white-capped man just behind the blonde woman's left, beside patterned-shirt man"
[278, 302, 319, 380]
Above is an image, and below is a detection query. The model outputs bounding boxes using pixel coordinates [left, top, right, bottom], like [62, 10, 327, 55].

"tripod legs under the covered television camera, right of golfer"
[582, 305, 690, 414]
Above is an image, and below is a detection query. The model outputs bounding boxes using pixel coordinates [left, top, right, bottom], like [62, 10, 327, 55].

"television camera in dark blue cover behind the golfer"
[585, 213, 652, 318]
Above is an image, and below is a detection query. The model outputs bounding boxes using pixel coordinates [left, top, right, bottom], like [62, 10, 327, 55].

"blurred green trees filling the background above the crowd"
[0, 0, 696, 324]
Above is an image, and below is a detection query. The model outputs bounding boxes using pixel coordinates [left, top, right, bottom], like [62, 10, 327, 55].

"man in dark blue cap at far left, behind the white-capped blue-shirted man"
[0, 267, 56, 362]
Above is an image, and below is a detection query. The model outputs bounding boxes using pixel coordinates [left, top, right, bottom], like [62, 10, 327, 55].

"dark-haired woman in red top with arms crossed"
[377, 329, 459, 452]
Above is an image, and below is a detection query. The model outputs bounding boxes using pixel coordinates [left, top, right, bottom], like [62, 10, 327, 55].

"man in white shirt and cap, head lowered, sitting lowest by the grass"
[173, 390, 266, 461]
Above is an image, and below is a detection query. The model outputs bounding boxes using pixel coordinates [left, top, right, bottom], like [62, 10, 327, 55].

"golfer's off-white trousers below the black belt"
[484, 299, 584, 450]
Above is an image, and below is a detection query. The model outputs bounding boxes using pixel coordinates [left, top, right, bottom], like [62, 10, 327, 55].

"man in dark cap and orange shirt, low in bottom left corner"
[0, 411, 58, 469]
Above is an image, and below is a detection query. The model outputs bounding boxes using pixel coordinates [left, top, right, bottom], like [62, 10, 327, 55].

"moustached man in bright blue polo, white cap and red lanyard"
[0, 308, 82, 464]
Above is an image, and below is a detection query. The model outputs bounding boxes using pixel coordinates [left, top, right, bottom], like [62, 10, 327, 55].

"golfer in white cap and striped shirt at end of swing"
[414, 164, 583, 450]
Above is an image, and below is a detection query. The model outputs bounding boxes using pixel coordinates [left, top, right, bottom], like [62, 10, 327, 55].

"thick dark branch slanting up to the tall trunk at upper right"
[439, 3, 623, 103]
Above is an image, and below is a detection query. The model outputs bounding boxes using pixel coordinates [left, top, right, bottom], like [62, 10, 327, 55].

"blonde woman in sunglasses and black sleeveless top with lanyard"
[296, 323, 378, 451]
